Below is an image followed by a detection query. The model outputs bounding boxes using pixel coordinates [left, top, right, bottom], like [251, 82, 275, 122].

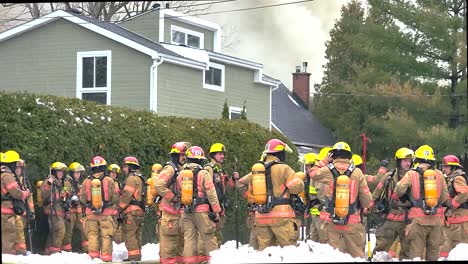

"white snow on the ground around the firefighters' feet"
[2, 234, 468, 264]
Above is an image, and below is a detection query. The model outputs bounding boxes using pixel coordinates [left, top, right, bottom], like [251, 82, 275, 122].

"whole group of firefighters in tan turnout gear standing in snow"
[0, 139, 468, 263]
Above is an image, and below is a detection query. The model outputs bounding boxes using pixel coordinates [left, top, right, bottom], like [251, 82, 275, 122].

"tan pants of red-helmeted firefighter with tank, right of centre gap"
[255, 218, 299, 251]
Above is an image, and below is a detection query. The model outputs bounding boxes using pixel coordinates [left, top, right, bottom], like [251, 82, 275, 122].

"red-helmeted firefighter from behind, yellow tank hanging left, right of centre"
[238, 139, 304, 251]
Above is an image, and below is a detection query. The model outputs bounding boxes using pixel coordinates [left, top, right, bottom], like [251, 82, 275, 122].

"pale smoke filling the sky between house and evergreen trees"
[200, 0, 349, 92]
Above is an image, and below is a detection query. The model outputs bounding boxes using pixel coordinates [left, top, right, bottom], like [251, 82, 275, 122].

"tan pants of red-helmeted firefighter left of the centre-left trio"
[122, 211, 144, 260]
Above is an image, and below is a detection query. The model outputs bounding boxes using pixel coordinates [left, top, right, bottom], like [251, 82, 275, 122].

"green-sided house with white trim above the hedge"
[0, 9, 278, 128]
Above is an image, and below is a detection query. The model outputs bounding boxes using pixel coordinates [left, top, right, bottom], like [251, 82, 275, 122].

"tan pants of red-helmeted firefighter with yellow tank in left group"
[85, 216, 115, 262]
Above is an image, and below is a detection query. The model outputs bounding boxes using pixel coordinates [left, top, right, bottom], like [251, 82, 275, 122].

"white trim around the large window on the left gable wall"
[76, 50, 112, 105]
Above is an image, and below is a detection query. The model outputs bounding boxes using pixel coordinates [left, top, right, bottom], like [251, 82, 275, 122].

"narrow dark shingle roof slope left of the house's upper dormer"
[61, 11, 185, 58]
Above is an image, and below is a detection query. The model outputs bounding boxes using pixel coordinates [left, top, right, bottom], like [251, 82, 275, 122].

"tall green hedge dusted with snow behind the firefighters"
[0, 92, 299, 253]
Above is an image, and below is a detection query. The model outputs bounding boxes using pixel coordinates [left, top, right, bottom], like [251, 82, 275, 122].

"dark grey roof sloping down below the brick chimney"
[268, 82, 335, 146]
